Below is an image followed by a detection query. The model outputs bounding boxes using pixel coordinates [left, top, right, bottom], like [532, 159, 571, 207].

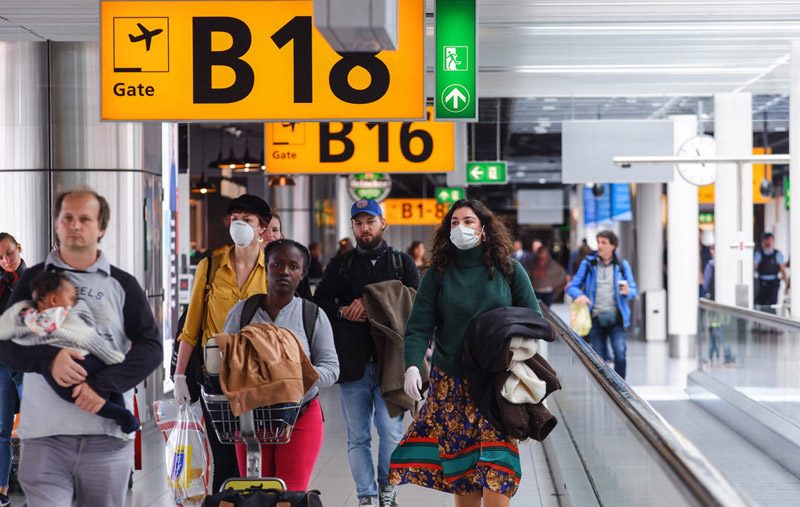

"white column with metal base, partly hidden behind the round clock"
[667, 115, 700, 357]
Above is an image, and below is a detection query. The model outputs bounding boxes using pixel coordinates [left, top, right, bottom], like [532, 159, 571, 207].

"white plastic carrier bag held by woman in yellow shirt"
[156, 399, 210, 506]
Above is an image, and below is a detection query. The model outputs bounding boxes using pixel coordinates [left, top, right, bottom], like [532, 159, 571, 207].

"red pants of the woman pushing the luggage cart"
[236, 399, 324, 491]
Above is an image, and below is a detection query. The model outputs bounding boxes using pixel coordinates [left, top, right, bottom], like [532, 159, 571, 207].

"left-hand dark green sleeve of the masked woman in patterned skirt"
[403, 267, 440, 370]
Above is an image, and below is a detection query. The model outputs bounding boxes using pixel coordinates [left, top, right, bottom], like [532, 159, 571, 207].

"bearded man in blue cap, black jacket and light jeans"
[314, 199, 419, 507]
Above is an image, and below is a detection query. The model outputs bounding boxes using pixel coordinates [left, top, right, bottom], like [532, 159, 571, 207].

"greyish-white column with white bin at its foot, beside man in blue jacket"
[635, 183, 667, 341]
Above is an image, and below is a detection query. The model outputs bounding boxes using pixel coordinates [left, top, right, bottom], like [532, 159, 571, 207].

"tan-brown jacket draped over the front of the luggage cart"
[216, 324, 319, 417]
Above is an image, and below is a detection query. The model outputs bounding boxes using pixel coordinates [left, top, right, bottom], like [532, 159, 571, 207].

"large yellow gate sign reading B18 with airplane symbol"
[100, 0, 425, 121]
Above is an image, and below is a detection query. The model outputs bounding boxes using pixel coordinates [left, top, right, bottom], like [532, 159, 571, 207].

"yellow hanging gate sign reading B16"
[264, 107, 455, 174]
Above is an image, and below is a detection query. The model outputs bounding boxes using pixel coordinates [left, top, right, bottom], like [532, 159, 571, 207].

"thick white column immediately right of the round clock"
[714, 93, 753, 308]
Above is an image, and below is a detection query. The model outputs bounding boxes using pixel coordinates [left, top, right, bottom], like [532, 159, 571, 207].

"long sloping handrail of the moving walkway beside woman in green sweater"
[542, 307, 753, 507]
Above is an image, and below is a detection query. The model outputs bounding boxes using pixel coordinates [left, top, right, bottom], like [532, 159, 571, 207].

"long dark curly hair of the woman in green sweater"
[431, 199, 514, 280]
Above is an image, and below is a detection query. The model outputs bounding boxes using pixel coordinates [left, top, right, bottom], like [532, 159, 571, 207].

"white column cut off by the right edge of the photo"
[784, 41, 800, 320]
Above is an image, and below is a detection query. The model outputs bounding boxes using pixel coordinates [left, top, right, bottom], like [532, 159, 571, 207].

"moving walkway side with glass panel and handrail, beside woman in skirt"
[543, 309, 753, 507]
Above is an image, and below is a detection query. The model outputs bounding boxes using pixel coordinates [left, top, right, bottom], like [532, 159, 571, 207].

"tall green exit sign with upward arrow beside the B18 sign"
[434, 0, 478, 121]
